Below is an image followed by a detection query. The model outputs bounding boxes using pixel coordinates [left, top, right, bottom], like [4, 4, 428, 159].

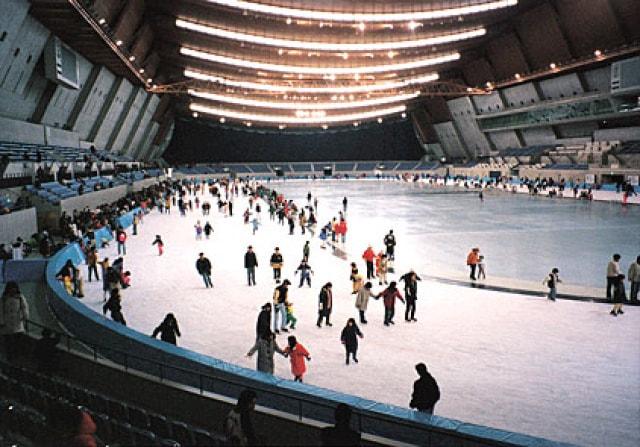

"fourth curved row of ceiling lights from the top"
[184, 69, 439, 94]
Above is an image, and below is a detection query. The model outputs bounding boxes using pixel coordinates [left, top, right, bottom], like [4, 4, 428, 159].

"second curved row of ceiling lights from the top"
[176, 19, 487, 54]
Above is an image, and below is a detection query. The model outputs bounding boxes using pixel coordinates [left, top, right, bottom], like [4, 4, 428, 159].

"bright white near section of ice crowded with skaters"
[83, 179, 640, 447]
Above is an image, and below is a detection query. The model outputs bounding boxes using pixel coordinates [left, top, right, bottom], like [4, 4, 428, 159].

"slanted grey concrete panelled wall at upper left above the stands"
[0, 4, 172, 159]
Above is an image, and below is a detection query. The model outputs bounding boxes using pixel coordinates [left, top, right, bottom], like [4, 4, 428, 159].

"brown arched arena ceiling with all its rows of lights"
[32, 0, 640, 129]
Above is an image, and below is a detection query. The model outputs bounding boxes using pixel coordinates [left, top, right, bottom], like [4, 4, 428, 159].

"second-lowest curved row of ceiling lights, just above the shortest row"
[188, 89, 418, 110]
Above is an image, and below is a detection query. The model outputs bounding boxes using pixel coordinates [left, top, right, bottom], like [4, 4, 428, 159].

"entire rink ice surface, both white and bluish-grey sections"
[83, 181, 640, 447]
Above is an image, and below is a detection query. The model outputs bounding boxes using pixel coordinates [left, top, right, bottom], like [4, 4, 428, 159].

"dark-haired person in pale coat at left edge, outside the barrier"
[0, 281, 29, 361]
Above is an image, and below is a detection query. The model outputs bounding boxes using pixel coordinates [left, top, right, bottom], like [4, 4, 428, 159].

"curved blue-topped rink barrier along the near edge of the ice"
[46, 244, 570, 447]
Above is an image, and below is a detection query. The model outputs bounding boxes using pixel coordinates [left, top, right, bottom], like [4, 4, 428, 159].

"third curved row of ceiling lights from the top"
[180, 47, 460, 75]
